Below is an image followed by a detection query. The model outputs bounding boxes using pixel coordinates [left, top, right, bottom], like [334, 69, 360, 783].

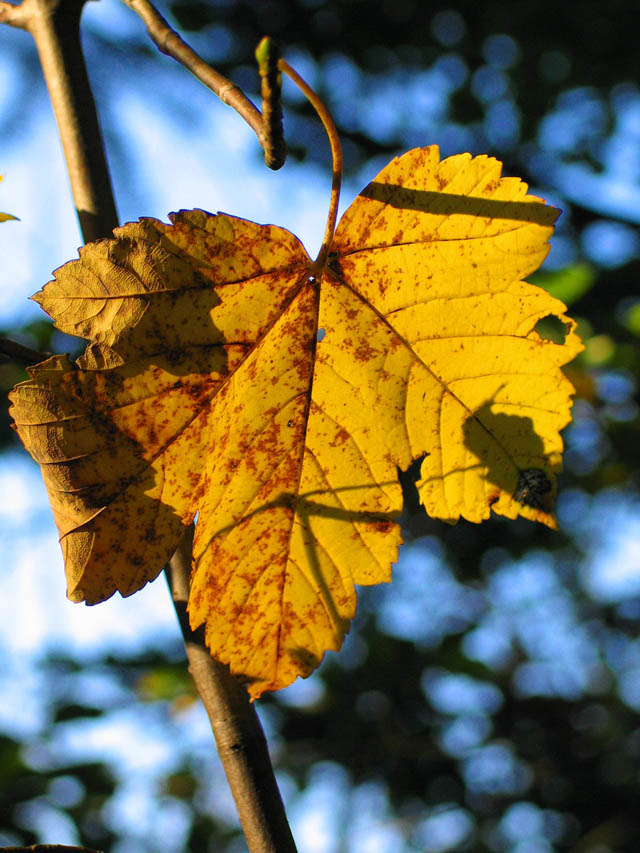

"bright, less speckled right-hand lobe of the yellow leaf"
[332, 147, 581, 526]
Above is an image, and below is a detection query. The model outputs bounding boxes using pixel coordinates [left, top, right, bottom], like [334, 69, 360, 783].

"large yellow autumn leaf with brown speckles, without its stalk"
[8, 146, 581, 697]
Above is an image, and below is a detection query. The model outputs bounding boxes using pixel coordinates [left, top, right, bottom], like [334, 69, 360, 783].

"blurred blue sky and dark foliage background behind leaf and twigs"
[0, 0, 640, 853]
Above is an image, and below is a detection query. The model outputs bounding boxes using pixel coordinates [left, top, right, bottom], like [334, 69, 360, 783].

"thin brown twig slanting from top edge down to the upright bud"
[123, 0, 264, 147]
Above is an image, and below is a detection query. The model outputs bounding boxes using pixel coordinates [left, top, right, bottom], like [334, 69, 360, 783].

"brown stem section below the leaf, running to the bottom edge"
[165, 526, 296, 853]
